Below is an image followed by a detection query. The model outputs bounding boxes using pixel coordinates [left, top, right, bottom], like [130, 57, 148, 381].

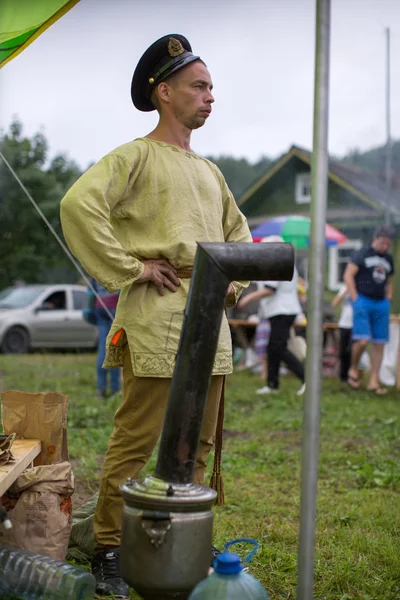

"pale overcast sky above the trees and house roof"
[0, 0, 400, 167]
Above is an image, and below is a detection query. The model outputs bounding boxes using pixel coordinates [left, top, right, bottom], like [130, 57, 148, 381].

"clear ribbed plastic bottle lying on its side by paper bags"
[0, 547, 96, 600]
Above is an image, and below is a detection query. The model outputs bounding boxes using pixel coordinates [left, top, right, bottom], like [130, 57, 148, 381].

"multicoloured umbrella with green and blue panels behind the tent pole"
[251, 215, 347, 248]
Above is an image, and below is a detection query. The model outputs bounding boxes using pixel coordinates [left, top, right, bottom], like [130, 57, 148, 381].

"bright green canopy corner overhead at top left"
[0, 0, 79, 69]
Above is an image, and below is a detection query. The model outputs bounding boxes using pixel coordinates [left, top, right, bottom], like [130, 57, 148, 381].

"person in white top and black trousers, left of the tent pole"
[238, 235, 305, 395]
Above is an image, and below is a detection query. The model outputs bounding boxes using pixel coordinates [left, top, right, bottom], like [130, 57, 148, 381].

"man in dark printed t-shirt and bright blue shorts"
[344, 226, 395, 395]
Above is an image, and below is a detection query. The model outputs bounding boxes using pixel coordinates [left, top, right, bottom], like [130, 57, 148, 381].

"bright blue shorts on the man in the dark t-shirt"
[353, 294, 390, 344]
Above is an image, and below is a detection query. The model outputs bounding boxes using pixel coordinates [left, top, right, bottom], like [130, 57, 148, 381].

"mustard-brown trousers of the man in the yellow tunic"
[93, 346, 223, 550]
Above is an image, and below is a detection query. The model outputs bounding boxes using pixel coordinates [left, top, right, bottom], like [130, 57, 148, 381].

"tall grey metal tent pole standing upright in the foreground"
[297, 0, 330, 600]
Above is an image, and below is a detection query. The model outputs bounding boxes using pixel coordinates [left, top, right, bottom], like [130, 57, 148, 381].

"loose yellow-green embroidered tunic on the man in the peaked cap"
[61, 138, 252, 377]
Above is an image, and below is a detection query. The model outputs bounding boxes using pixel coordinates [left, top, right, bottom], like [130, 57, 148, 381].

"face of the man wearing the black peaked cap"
[169, 60, 214, 129]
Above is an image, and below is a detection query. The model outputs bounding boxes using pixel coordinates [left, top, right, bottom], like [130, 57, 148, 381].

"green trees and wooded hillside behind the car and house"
[0, 120, 400, 290]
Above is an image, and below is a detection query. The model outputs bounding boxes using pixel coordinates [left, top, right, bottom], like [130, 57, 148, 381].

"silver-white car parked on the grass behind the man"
[0, 284, 97, 354]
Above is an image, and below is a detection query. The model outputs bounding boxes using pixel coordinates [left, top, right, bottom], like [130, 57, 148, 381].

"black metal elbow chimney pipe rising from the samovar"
[155, 243, 294, 484]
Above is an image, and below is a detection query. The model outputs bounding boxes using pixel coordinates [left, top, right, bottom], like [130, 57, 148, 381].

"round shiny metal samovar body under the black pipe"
[121, 477, 216, 600]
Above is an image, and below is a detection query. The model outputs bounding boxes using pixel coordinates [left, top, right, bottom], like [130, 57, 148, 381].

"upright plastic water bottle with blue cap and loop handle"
[188, 538, 268, 600]
